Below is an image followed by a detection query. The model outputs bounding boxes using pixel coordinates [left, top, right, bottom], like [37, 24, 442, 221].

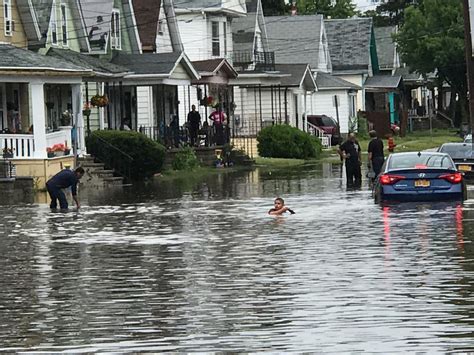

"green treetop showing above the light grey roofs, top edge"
[296, 0, 356, 18]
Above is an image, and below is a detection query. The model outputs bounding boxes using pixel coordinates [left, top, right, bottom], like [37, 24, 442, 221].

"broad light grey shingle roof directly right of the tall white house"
[266, 15, 323, 68]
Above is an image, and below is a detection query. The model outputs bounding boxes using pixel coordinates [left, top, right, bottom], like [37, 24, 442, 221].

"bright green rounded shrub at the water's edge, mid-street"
[257, 125, 321, 159]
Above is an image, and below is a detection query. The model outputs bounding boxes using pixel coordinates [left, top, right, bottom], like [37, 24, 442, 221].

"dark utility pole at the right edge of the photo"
[463, 0, 474, 133]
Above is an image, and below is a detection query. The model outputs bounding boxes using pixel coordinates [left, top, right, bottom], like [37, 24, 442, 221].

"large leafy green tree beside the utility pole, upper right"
[395, 0, 467, 125]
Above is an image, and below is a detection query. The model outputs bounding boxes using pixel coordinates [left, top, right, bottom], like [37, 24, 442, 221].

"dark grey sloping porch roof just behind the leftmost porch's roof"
[46, 48, 129, 76]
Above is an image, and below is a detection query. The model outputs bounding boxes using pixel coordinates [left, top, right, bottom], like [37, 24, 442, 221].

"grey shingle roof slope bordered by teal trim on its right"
[324, 18, 372, 71]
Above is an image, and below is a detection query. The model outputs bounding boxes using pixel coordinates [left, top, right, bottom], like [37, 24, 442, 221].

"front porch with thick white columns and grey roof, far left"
[0, 44, 92, 187]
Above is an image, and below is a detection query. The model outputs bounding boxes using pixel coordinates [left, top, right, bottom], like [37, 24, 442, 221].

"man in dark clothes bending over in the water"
[46, 167, 84, 210]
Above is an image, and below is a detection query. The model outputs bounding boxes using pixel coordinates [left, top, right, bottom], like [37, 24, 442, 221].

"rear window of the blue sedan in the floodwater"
[389, 154, 455, 170]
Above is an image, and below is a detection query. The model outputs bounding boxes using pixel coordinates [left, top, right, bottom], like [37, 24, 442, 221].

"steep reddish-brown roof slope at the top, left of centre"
[133, 0, 161, 50]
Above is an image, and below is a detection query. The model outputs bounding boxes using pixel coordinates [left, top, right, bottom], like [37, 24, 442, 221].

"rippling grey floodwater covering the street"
[0, 164, 474, 353]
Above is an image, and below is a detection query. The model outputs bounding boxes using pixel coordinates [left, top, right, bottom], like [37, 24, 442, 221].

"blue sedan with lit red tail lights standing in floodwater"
[374, 152, 467, 202]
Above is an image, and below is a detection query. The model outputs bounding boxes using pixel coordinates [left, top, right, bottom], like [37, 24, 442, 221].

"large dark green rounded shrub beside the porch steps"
[86, 130, 165, 180]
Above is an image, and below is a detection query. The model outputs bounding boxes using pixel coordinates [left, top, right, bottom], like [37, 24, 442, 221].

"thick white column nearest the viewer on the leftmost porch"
[29, 82, 48, 159]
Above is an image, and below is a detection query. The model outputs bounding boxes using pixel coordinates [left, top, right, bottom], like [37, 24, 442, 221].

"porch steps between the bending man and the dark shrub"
[78, 156, 124, 187]
